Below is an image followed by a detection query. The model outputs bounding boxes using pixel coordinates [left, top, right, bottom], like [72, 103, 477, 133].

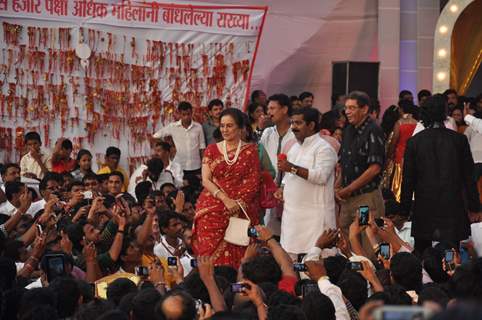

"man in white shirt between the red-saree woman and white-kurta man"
[259, 94, 296, 236]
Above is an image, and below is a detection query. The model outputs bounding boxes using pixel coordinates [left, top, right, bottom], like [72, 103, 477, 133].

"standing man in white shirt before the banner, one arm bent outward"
[153, 101, 206, 184]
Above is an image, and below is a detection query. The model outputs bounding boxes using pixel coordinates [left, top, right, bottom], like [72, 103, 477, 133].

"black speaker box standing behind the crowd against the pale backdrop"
[331, 61, 380, 99]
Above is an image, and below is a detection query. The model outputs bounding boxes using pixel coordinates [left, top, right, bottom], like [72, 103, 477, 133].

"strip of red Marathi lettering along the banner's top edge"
[0, 0, 266, 36]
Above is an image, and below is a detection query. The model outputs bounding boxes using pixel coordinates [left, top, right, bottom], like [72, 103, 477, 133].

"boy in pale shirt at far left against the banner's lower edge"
[20, 132, 52, 179]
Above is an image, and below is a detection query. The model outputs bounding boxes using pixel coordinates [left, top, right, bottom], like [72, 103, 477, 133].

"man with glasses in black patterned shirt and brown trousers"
[336, 91, 385, 252]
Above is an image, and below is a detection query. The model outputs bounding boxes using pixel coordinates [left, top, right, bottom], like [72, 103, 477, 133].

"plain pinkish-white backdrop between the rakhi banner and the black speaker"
[188, 0, 380, 111]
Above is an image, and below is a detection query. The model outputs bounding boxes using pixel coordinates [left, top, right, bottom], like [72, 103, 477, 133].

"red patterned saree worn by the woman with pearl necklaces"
[192, 144, 260, 269]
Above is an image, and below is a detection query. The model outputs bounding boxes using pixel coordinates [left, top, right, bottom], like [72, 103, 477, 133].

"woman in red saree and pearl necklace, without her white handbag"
[192, 109, 260, 269]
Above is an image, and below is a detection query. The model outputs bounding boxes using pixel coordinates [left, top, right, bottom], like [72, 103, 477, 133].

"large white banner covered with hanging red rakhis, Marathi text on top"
[0, 0, 267, 169]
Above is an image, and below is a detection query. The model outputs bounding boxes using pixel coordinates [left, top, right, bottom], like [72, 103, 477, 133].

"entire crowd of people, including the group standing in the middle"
[0, 90, 482, 320]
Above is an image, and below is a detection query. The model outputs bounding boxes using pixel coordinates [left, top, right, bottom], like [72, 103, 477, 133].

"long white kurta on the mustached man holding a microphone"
[281, 134, 338, 254]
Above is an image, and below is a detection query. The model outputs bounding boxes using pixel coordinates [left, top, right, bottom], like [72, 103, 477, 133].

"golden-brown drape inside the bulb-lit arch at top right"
[450, 0, 482, 95]
